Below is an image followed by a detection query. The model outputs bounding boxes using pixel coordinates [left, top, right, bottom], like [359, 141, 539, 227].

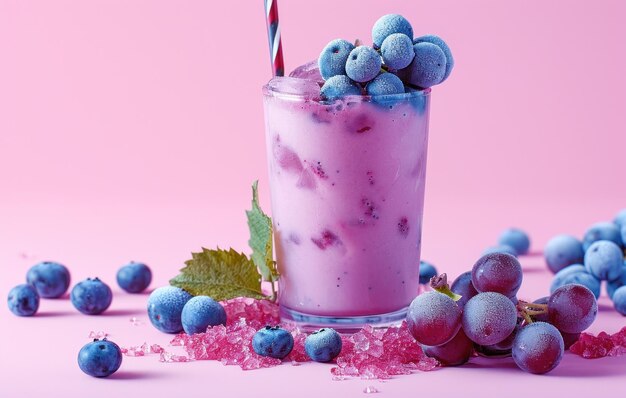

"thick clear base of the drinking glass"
[280, 305, 409, 333]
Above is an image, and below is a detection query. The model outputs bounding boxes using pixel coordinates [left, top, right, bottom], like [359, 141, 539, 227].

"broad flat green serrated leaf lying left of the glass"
[170, 248, 268, 301]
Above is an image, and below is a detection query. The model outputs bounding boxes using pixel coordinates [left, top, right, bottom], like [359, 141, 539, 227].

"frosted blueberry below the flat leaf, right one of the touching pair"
[181, 296, 226, 334]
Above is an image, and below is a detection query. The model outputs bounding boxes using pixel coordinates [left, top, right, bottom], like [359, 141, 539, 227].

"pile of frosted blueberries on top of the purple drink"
[318, 14, 454, 100]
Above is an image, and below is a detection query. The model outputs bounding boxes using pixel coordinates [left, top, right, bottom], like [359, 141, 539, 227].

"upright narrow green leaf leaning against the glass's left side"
[246, 181, 279, 282]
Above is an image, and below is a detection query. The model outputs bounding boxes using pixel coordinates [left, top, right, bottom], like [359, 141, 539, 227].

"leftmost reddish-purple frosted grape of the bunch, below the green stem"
[406, 291, 461, 346]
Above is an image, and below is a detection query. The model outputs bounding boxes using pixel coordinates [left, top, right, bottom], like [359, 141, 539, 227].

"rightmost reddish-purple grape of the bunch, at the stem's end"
[548, 284, 598, 333]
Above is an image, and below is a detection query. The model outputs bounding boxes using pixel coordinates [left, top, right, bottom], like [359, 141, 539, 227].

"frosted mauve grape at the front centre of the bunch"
[463, 292, 517, 345]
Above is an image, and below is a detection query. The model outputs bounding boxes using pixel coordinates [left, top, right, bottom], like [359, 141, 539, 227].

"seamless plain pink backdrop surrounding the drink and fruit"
[0, 0, 626, 396]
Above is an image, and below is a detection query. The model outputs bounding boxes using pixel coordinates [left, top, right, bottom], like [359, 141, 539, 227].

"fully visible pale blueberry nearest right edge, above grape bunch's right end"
[585, 240, 624, 281]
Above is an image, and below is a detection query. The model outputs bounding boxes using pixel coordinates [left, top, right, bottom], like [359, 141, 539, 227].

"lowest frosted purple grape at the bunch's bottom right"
[512, 322, 565, 374]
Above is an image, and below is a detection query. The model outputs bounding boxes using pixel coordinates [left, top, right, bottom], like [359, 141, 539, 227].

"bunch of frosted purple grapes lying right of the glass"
[407, 253, 598, 374]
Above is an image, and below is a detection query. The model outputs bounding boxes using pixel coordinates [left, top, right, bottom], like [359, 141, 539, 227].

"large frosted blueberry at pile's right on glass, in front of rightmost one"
[407, 42, 446, 88]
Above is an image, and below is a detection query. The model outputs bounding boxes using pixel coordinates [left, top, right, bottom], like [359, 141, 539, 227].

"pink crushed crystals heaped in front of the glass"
[170, 298, 439, 380]
